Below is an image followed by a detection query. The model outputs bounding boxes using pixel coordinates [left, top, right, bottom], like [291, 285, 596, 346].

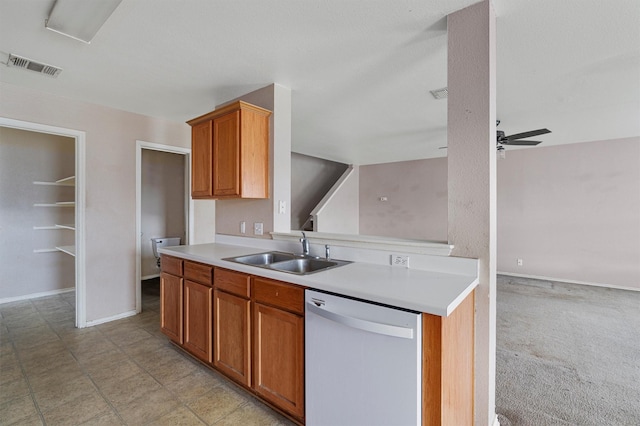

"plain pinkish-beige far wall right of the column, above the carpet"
[498, 137, 640, 290]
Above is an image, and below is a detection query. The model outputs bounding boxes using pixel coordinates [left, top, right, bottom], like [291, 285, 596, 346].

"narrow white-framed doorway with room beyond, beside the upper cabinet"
[136, 141, 193, 313]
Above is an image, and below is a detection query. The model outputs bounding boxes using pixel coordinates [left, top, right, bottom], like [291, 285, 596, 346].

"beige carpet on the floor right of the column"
[496, 276, 640, 426]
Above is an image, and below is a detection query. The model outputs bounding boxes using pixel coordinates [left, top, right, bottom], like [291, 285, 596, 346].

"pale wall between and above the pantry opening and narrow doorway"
[0, 80, 205, 322]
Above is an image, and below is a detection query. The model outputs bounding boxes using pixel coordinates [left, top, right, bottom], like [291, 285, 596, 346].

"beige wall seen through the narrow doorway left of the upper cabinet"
[140, 149, 189, 279]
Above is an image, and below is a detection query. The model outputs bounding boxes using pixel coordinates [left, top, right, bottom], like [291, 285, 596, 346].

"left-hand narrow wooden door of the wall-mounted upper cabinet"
[191, 121, 213, 198]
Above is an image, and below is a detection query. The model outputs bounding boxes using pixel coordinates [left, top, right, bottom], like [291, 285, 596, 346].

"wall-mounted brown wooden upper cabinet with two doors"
[188, 101, 271, 199]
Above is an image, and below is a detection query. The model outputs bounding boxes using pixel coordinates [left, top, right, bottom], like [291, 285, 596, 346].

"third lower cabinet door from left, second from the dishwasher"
[213, 289, 251, 387]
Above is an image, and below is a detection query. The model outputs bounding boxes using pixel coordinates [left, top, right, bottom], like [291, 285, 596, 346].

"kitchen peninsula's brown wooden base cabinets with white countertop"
[160, 238, 478, 425]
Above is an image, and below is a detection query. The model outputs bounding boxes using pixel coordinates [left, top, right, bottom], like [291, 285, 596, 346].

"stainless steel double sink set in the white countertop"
[222, 251, 351, 275]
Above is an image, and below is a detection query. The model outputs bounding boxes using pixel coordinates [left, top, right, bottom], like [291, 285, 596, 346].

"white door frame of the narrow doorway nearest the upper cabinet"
[136, 140, 194, 314]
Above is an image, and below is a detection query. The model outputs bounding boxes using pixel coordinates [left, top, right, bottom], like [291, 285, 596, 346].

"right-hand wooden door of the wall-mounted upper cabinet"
[213, 111, 240, 197]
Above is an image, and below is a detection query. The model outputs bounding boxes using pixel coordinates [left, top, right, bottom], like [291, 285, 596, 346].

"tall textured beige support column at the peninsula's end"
[447, 0, 496, 425]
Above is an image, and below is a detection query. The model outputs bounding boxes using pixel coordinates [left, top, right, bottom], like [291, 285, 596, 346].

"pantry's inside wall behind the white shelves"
[0, 127, 75, 300]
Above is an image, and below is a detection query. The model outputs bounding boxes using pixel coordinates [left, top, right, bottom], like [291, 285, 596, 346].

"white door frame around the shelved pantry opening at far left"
[0, 117, 87, 328]
